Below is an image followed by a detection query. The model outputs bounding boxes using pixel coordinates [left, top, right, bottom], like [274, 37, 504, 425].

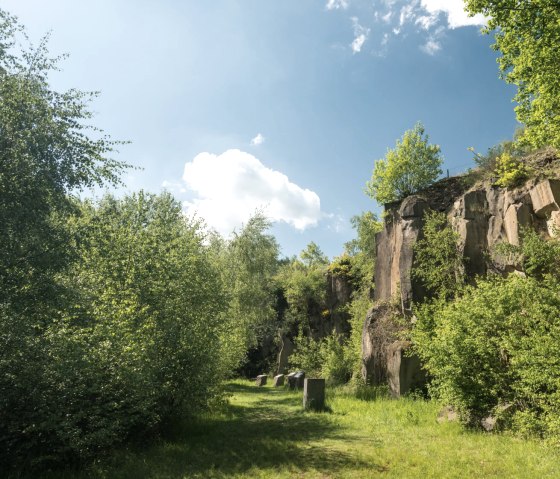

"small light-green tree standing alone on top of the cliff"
[366, 123, 443, 203]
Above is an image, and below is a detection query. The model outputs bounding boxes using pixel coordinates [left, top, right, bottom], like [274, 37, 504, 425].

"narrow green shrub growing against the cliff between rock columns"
[412, 211, 465, 298]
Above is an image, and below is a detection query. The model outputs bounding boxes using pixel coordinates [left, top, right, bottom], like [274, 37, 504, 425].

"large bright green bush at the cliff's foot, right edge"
[415, 275, 560, 439]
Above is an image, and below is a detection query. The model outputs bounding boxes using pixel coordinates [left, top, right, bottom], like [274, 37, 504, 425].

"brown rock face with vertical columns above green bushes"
[362, 177, 560, 394]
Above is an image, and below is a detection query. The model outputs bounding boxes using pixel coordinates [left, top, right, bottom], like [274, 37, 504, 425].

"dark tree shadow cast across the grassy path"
[59, 384, 384, 479]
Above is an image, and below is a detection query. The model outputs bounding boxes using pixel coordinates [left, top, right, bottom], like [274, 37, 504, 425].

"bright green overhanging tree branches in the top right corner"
[465, 0, 560, 148]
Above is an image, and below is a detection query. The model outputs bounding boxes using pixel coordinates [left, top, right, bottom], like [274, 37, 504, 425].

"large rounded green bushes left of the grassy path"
[0, 192, 230, 467]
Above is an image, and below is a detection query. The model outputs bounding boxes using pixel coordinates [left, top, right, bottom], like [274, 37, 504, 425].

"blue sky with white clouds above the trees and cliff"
[0, 0, 517, 258]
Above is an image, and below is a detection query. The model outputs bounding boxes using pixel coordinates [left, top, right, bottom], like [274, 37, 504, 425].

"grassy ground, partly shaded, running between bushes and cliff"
[40, 381, 560, 479]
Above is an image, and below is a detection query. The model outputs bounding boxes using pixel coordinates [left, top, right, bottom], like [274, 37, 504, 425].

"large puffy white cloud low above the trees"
[183, 150, 321, 234]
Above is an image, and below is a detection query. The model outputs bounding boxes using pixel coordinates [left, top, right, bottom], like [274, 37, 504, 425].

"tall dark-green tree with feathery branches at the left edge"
[0, 9, 125, 312]
